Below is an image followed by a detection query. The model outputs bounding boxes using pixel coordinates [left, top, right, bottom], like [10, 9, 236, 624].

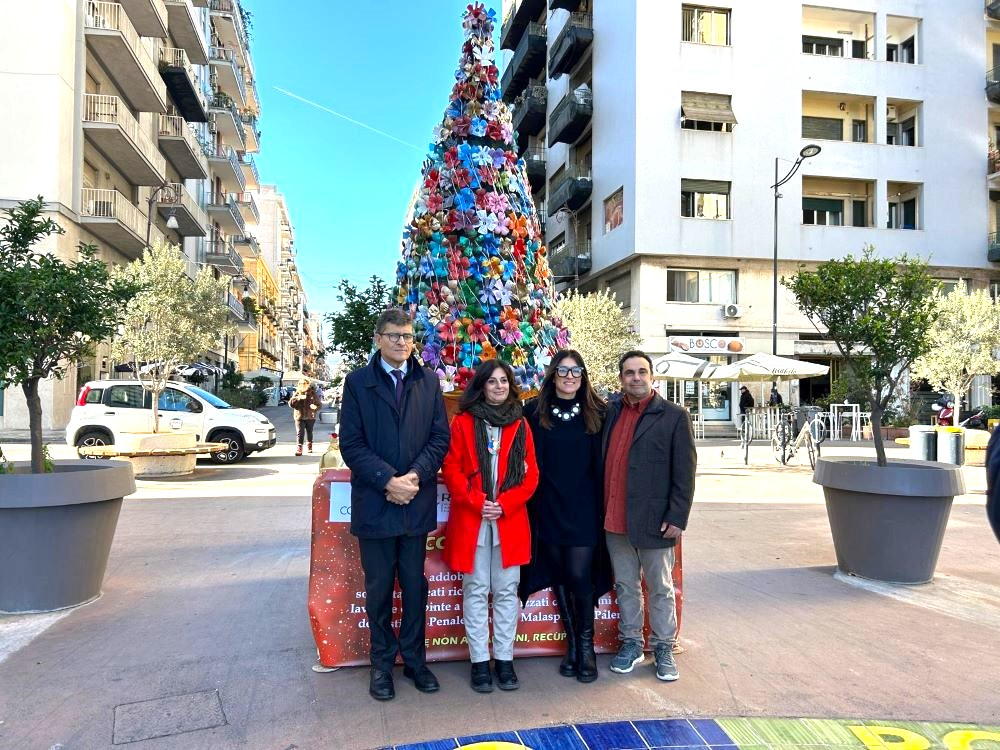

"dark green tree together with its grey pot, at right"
[782, 246, 965, 583]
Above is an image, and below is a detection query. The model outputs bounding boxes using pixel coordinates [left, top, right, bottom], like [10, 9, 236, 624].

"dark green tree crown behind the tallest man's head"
[326, 276, 392, 369]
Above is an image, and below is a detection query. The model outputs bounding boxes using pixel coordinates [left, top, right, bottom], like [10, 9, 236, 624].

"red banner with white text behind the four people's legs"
[309, 469, 683, 667]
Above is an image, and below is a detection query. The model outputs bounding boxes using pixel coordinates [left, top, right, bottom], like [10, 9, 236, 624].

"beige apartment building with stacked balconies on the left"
[0, 0, 296, 427]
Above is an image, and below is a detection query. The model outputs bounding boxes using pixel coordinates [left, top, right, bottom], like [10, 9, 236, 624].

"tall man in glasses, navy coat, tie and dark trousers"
[340, 309, 450, 700]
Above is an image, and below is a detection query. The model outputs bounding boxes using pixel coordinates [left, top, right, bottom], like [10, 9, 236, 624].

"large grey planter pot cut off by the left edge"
[0, 460, 135, 613]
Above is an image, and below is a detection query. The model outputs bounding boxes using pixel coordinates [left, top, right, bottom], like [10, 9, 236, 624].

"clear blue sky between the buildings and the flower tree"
[242, 0, 501, 320]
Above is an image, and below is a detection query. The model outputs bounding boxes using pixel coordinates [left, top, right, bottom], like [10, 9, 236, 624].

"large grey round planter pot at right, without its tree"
[813, 456, 965, 583]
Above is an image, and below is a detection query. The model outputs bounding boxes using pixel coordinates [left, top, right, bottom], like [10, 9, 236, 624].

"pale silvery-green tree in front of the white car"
[112, 245, 233, 432]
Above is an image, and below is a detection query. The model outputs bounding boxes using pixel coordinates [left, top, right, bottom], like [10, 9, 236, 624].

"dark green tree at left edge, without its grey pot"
[0, 196, 141, 474]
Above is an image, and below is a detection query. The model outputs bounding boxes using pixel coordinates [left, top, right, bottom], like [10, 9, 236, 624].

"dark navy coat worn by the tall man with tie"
[340, 352, 451, 539]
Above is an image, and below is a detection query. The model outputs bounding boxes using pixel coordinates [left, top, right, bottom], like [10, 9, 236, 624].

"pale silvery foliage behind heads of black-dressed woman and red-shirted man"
[553, 289, 640, 391]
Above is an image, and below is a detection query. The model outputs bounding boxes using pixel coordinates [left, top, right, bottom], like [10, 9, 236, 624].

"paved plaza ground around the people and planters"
[0, 407, 1000, 750]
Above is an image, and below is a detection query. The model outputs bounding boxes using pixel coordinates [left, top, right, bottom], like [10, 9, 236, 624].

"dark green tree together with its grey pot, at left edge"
[0, 197, 138, 612]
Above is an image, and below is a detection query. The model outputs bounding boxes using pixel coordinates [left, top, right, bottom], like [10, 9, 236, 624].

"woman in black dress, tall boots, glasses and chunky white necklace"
[521, 349, 610, 682]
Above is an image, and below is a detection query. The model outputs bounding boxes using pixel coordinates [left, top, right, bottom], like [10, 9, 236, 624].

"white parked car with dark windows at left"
[66, 380, 277, 464]
